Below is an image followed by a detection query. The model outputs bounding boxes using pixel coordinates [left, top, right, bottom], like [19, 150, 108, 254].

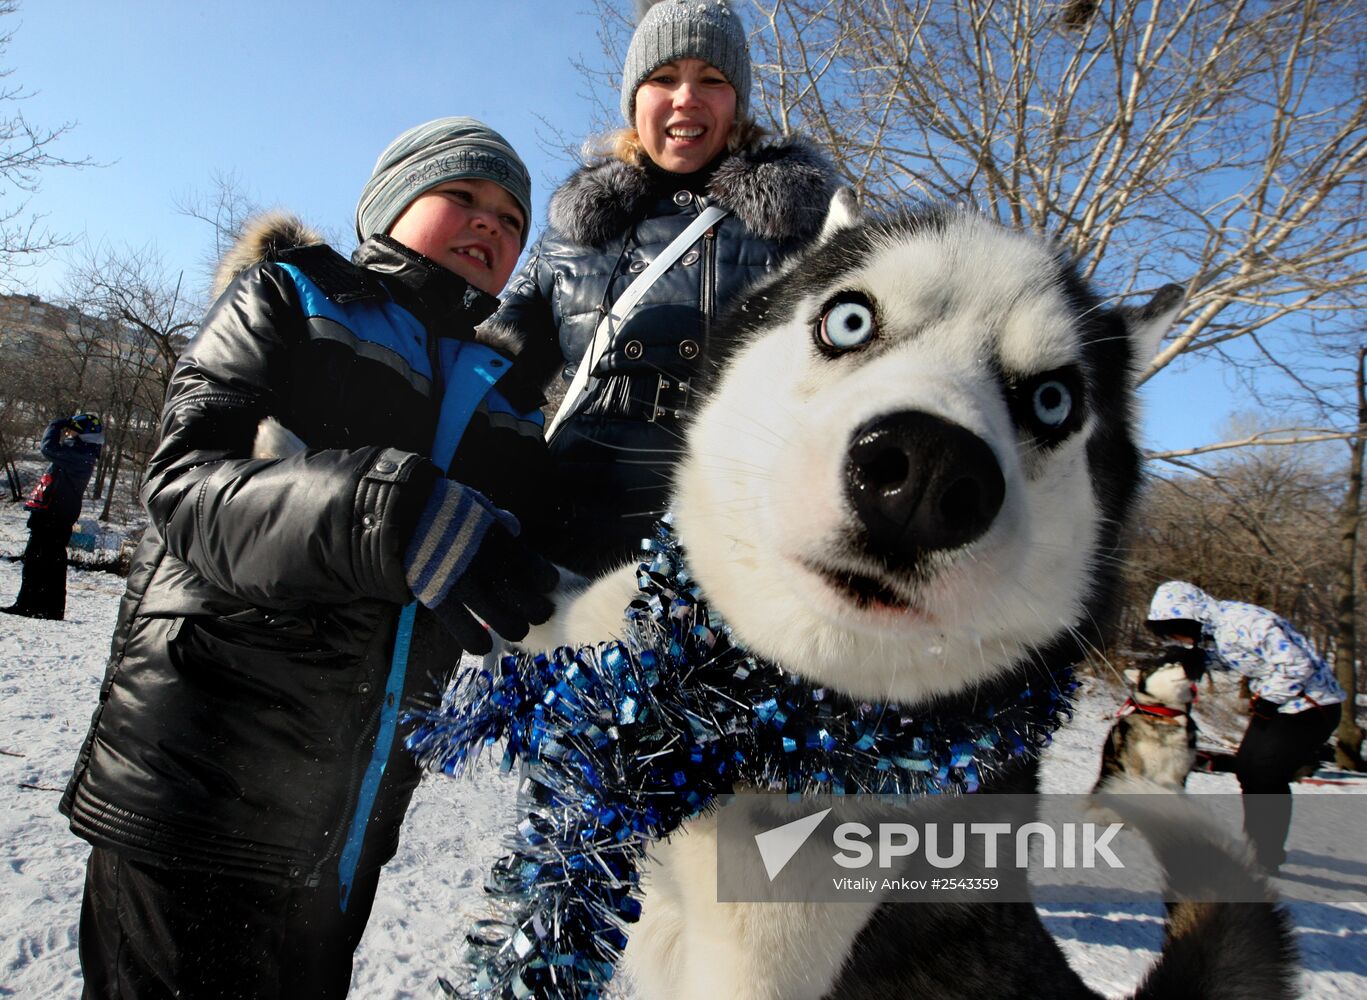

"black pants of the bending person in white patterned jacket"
[1234, 705, 1341, 870]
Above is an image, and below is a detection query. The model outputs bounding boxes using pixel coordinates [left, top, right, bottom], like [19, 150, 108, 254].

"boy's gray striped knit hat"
[355, 117, 532, 246]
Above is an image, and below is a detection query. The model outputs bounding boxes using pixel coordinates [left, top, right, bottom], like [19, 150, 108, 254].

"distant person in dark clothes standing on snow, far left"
[0, 413, 104, 622]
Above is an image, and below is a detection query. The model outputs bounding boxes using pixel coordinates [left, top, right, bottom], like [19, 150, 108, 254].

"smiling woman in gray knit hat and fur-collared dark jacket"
[491, 0, 834, 575]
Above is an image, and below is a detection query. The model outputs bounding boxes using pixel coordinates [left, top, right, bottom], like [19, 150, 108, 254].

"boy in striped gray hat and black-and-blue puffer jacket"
[62, 117, 556, 1000]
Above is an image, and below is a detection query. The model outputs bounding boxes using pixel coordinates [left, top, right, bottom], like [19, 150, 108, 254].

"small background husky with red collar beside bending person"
[1092, 646, 1206, 792]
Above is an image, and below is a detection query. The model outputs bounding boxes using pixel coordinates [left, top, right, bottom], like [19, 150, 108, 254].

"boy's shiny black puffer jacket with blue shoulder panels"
[62, 221, 560, 885]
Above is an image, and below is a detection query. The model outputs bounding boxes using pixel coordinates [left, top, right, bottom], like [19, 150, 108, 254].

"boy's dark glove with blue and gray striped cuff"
[403, 480, 559, 654]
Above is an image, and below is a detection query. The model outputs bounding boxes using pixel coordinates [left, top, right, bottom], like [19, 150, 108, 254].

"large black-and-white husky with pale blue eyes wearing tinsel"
[528, 195, 1292, 1000]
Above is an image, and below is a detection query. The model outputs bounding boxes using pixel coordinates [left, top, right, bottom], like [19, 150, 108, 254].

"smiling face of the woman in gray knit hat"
[636, 59, 735, 173]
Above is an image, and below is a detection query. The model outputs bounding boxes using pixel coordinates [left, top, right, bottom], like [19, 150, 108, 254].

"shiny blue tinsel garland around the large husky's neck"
[407, 525, 1074, 1000]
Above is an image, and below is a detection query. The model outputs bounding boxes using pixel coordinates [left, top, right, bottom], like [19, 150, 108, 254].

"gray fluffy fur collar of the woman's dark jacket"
[550, 138, 835, 246]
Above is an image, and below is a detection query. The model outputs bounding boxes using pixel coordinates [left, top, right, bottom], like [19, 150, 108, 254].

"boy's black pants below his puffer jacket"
[81, 847, 380, 1000]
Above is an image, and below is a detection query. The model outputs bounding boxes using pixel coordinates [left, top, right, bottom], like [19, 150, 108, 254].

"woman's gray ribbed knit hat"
[622, 0, 750, 126]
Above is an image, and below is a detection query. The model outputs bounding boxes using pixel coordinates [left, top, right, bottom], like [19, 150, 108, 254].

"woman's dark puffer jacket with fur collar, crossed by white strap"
[489, 139, 835, 575]
